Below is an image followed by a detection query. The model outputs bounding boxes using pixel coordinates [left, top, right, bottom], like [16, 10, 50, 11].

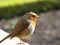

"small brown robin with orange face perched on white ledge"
[0, 11, 39, 43]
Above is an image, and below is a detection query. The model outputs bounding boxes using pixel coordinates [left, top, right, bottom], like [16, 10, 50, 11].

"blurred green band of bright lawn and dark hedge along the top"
[0, 0, 60, 19]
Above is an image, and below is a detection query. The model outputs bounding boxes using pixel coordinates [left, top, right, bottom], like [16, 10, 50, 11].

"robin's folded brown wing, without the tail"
[10, 21, 30, 38]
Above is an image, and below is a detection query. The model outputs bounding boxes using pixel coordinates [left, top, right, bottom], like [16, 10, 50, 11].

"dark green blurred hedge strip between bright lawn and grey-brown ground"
[0, 1, 60, 18]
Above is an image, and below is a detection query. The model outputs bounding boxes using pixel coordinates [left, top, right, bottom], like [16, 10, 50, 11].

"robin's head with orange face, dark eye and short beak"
[23, 12, 39, 22]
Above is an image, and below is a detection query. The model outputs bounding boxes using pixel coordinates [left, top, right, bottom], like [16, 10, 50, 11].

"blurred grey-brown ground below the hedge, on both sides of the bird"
[0, 10, 60, 45]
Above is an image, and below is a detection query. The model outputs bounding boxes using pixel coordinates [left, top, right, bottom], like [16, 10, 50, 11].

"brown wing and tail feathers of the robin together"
[0, 20, 29, 43]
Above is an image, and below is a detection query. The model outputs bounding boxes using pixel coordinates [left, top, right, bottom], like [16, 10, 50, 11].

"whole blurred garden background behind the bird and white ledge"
[0, 0, 60, 45]
